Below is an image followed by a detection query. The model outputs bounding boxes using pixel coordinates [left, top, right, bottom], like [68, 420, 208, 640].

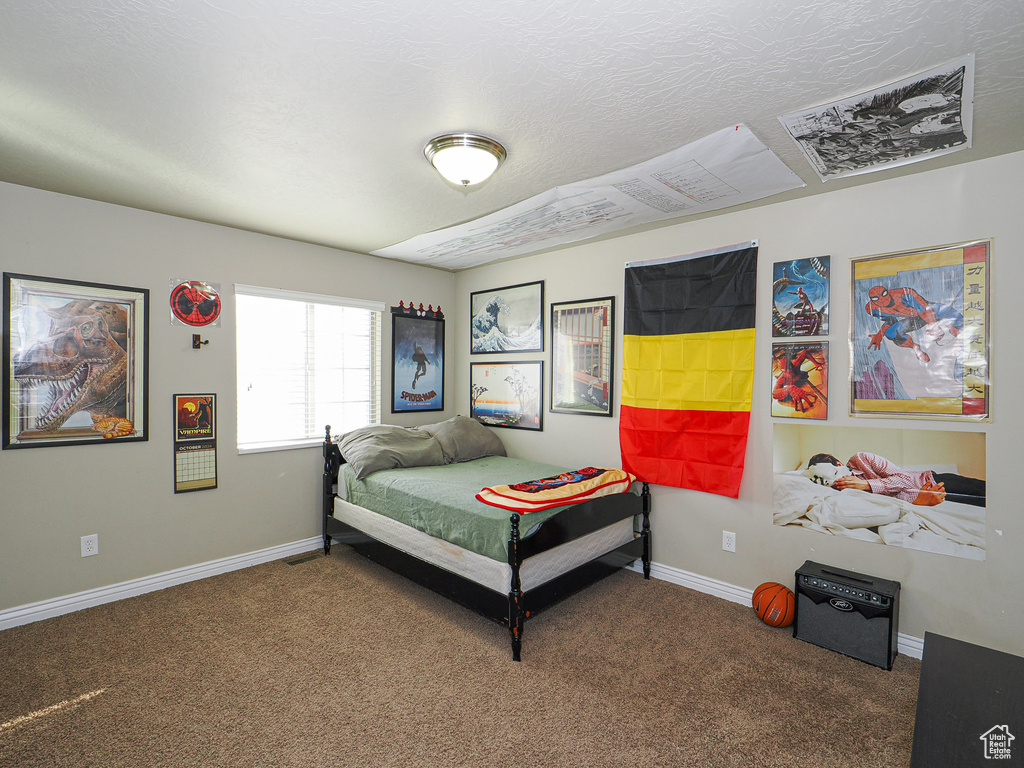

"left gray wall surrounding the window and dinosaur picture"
[0, 184, 454, 609]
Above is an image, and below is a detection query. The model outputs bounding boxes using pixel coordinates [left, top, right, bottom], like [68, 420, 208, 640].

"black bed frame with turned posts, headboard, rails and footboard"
[323, 426, 651, 662]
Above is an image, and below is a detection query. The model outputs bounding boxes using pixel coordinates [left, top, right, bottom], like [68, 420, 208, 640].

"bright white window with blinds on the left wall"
[234, 285, 384, 454]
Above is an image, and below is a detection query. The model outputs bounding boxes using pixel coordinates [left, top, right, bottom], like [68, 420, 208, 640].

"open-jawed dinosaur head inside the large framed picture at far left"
[12, 299, 134, 438]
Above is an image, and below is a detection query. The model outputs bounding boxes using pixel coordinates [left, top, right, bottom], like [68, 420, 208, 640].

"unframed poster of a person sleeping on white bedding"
[772, 423, 986, 560]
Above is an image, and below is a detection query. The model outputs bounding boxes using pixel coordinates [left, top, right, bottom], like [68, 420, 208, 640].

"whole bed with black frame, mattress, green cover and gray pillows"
[323, 416, 651, 662]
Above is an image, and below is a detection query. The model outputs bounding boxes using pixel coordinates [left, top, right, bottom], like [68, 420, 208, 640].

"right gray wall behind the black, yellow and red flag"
[451, 153, 1024, 653]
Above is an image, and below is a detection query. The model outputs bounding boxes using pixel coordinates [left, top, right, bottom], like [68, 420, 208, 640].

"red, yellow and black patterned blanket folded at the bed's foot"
[476, 467, 636, 515]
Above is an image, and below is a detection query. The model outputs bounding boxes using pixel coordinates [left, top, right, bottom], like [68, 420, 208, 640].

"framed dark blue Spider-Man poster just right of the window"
[391, 303, 444, 414]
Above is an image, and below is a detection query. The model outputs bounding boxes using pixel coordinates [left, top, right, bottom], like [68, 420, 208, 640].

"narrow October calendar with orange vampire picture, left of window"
[174, 394, 217, 494]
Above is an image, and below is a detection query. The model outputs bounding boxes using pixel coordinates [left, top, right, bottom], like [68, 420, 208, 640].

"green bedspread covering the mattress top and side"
[342, 456, 638, 562]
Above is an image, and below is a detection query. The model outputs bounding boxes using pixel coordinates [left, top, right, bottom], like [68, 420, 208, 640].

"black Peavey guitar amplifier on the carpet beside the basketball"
[793, 560, 900, 670]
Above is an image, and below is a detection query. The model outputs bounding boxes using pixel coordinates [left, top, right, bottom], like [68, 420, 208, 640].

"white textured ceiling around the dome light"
[0, 0, 1024, 270]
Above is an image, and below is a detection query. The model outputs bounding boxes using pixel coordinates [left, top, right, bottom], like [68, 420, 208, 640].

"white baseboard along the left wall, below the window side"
[0, 536, 324, 631]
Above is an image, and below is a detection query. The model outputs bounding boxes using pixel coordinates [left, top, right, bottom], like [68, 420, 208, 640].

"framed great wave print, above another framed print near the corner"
[469, 281, 544, 354]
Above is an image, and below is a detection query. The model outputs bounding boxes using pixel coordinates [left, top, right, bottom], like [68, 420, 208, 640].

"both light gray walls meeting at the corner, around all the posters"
[0, 153, 1024, 653]
